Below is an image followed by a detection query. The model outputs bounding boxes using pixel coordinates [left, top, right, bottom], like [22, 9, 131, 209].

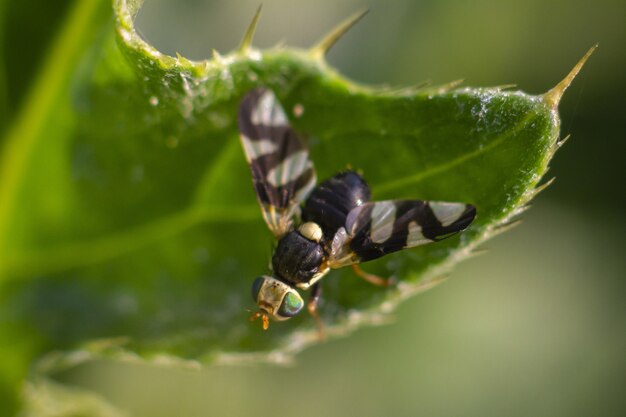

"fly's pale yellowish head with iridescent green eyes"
[252, 275, 304, 321]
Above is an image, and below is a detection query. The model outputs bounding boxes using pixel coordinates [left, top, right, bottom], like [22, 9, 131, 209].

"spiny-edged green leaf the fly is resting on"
[0, 0, 591, 400]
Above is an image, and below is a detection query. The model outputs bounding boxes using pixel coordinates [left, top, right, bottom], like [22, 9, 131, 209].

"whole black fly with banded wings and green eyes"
[238, 88, 476, 329]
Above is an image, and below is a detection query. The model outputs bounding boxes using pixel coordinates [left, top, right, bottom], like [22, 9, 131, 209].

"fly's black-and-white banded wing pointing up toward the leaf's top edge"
[239, 88, 316, 237]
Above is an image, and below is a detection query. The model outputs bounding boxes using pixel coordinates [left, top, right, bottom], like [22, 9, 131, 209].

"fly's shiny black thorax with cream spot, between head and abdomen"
[272, 223, 328, 285]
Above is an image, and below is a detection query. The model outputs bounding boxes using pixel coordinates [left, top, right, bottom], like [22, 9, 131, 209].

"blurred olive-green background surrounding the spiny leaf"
[0, 0, 626, 417]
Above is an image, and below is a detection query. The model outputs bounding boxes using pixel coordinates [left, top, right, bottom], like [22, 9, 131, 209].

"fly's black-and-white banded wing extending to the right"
[330, 200, 476, 268]
